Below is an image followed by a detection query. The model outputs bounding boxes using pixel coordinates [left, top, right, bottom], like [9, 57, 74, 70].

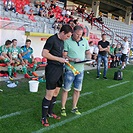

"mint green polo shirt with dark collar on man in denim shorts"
[64, 37, 90, 71]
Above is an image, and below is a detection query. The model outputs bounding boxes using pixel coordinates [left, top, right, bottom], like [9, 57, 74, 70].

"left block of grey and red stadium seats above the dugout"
[0, 0, 88, 36]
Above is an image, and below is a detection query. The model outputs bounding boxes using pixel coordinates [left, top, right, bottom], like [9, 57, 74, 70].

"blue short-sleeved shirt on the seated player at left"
[21, 46, 33, 59]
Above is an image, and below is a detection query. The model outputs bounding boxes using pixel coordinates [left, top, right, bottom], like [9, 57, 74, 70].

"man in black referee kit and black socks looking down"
[41, 25, 72, 127]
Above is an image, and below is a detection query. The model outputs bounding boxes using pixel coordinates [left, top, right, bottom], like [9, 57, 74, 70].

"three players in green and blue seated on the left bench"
[0, 39, 38, 79]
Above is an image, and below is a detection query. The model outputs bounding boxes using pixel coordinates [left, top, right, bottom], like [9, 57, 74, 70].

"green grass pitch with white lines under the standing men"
[0, 65, 133, 133]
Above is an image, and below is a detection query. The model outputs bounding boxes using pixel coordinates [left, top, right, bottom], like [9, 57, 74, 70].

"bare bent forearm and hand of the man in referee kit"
[42, 49, 66, 63]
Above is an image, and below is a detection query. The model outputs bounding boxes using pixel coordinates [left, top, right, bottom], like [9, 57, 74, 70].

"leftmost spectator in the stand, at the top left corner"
[4, 0, 16, 13]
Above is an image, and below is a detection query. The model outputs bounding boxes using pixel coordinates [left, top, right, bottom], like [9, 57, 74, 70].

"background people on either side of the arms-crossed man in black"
[89, 37, 130, 69]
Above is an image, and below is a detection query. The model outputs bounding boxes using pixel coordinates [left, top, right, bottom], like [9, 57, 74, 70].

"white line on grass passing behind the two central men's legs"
[0, 92, 93, 120]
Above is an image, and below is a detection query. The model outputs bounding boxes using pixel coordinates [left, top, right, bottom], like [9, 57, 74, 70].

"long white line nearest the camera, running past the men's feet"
[32, 92, 133, 133]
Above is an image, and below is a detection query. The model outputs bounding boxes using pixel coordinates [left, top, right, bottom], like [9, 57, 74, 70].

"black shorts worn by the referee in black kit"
[45, 64, 63, 90]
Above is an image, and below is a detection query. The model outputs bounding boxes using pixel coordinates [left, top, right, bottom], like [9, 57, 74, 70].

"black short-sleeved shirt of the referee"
[43, 34, 64, 65]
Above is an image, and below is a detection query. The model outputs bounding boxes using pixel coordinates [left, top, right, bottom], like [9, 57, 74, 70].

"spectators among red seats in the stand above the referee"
[4, 0, 86, 34]
